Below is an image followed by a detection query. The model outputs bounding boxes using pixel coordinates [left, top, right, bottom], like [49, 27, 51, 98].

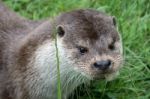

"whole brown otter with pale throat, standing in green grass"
[0, 2, 122, 99]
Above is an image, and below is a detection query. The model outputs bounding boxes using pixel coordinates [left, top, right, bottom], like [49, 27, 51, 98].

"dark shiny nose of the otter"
[93, 60, 111, 70]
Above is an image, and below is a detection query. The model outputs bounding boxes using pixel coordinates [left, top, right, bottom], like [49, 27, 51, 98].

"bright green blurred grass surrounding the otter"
[4, 0, 150, 99]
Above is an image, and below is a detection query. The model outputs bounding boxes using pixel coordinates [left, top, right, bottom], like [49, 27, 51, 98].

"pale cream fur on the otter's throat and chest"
[26, 41, 88, 99]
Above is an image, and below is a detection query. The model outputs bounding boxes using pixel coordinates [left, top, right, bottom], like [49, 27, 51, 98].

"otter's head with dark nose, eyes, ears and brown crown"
[57, 10, 122, 79]
